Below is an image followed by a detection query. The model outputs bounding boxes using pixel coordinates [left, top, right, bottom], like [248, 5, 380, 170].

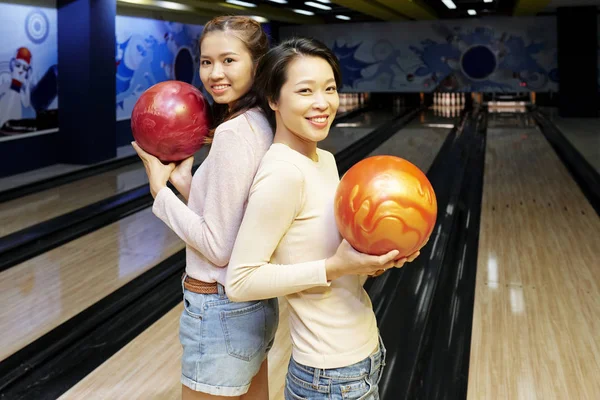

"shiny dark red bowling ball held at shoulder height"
[131, 81, 210, 163]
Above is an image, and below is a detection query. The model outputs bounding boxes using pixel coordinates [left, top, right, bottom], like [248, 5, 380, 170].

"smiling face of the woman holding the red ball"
[200, 32, 254, 106]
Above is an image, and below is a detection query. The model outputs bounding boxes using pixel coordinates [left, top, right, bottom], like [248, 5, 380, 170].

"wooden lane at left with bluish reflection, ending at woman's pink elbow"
[0, 209, 184, 361]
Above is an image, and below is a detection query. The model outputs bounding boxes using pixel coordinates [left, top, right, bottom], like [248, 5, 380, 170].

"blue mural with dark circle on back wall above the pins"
[281, 17, 558, 92]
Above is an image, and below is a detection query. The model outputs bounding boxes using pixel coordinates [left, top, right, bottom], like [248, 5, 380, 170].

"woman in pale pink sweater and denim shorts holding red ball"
[133, 16, 279, 400]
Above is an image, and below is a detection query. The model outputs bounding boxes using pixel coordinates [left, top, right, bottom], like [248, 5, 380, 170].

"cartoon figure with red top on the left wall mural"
[0, 47, 32, 128]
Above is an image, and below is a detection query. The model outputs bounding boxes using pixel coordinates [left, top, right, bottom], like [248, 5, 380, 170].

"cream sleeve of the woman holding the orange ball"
[226, 161, 329, 301]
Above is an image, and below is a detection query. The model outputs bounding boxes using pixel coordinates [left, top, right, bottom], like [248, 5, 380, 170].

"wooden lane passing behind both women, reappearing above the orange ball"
[61, 107, 460, 400]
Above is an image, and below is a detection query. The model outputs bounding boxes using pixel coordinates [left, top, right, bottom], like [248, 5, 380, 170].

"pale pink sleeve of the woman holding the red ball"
[152, 130, 256, 266]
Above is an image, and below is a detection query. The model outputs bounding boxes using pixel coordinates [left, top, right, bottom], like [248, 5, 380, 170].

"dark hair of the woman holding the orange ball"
[254, 38, 342, 131]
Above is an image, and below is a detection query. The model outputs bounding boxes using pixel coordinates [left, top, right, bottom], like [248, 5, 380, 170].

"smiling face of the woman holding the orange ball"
[270, 56, 340, 142]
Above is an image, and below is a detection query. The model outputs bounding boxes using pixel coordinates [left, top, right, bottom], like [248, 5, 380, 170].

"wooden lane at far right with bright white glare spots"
[468, 111, 600, 400]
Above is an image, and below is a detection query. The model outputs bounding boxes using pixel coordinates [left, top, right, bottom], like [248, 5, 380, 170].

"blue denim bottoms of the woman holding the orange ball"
[285, 336, 386, 400]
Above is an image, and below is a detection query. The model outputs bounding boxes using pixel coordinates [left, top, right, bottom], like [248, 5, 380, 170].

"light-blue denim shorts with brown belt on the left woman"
[179, 276, 279, 396]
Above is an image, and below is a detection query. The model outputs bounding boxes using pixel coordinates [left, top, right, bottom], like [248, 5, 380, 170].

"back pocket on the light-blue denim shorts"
[221, 301, 267, 361]
